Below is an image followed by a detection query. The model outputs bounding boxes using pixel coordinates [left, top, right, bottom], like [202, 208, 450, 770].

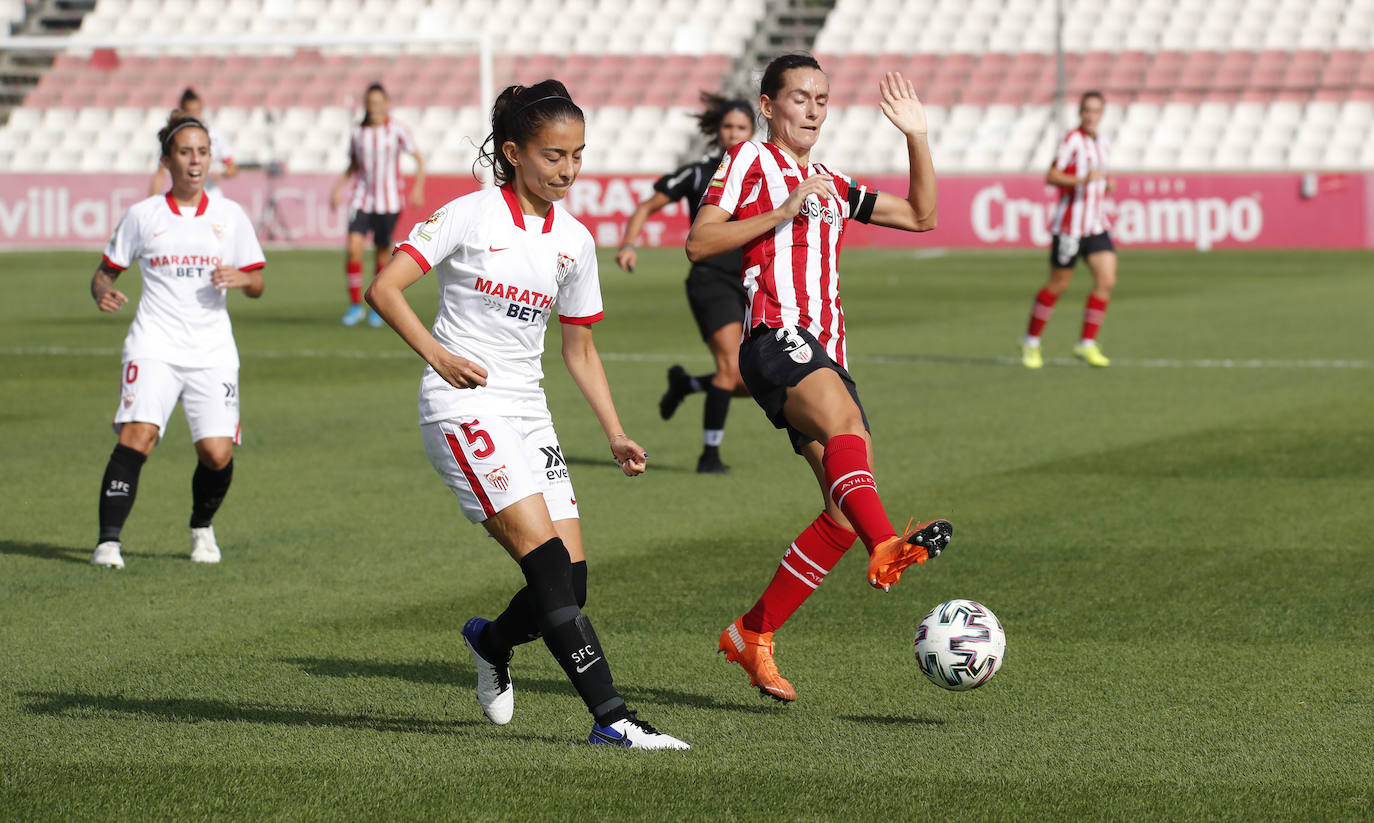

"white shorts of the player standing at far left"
[114, 360, 240, 442]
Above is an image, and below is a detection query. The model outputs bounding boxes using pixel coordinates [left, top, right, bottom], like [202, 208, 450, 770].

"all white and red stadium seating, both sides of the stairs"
[0, 0, 1374, 173]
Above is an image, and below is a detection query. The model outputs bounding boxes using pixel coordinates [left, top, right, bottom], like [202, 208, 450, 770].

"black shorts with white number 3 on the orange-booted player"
[739, 326, 868, 455]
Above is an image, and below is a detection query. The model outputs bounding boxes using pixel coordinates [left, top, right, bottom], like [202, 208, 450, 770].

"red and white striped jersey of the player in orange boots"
[701, 140, 868, 365]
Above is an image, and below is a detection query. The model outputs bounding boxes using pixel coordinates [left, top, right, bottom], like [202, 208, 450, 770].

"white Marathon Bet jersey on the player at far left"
[104, 192, 265, 368]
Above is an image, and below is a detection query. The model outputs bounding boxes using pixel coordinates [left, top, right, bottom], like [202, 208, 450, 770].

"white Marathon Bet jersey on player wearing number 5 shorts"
[397, 187, 602, 423]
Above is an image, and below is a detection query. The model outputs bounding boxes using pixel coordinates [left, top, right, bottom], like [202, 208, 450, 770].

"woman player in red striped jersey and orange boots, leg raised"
[687, 55, 954, 701]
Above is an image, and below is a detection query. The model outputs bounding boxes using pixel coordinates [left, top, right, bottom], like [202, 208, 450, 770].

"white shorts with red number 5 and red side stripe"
[420, 414, 577, 523]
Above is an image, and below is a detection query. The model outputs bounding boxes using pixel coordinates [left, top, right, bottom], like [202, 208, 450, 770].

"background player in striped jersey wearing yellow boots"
[1021, 92, 1116, 368]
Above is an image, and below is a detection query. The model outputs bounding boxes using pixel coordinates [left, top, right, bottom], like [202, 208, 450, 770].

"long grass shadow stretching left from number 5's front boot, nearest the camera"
[21, 692, 562, 742]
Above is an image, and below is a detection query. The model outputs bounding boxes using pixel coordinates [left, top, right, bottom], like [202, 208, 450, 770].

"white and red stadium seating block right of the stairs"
[815, 0, 1374, 173]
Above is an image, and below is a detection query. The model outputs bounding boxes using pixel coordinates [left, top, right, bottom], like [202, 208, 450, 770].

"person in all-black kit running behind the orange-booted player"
[616, 93, 754, 474]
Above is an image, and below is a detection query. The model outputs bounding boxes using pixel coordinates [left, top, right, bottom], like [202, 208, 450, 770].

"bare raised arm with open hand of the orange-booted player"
[871, 71, 936, 231]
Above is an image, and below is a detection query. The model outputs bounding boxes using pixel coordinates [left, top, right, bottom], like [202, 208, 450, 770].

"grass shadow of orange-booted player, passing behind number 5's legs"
[280, 656, 776, 713]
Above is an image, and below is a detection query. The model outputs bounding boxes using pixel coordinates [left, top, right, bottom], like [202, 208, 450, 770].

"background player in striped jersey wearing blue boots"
[330, 82, 425, 327]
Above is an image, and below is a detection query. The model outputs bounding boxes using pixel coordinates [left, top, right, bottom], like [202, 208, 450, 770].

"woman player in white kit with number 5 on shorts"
[367, 80, 688, 749]
